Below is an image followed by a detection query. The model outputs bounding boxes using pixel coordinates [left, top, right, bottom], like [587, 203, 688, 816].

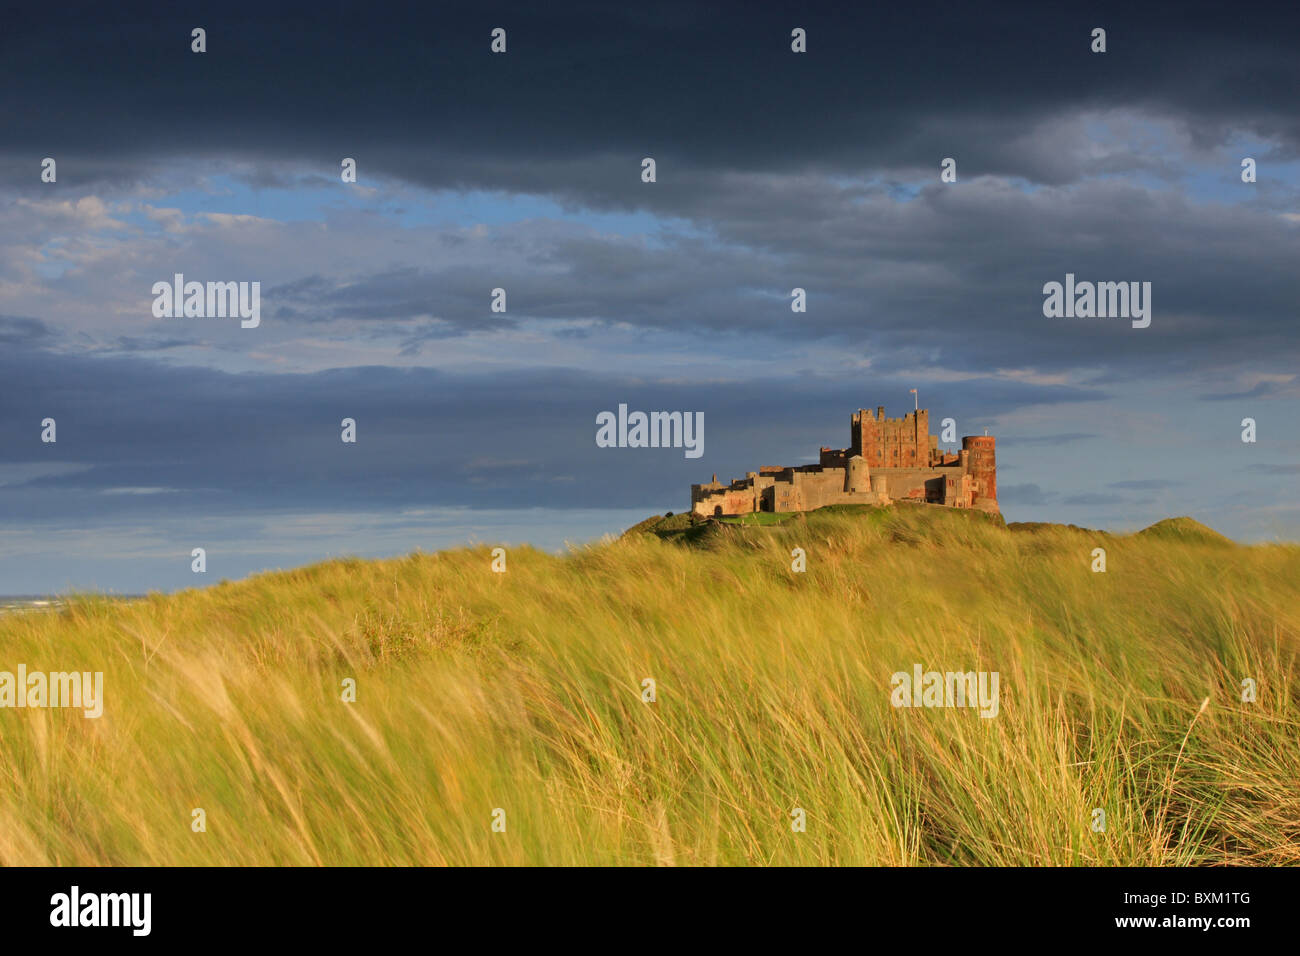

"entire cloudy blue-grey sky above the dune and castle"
[0, 3, 1300, 594]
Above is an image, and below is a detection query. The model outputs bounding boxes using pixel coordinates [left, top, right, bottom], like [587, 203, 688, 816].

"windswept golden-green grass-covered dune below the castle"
[0, 507, 1300, 865]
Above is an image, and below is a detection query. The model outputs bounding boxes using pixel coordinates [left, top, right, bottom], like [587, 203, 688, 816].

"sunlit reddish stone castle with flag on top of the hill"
[690, 406, 998, 516]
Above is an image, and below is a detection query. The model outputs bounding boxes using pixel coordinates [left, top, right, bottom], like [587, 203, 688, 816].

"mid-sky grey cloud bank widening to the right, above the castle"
[185, 178, 1300, 379]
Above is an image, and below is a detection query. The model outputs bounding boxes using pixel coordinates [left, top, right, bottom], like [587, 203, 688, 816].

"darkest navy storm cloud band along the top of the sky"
[0, 1, 1300, 193]
